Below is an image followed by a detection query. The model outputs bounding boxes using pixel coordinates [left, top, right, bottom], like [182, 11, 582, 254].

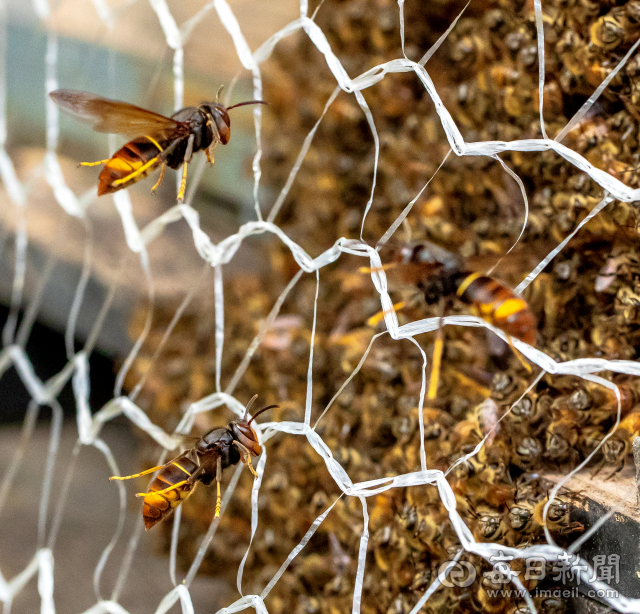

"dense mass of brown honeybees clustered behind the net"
[121, 0, 640, 614]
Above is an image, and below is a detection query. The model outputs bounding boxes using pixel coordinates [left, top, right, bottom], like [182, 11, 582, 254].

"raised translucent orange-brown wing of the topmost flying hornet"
[49, 90, 188, 137]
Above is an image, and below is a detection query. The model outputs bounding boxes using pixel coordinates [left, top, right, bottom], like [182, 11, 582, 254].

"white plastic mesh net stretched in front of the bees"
[0, 0, 640, 614]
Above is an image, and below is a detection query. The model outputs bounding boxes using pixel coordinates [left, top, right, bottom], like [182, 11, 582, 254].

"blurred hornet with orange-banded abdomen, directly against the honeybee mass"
[396, 241, 536, 345]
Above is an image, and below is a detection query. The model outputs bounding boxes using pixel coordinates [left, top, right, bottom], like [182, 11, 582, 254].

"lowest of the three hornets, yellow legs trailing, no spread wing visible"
[109, 394, 278, 531]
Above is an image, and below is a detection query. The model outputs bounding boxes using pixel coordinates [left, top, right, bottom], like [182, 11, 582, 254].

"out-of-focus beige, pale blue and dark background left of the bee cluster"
[0, 0, 299, 613]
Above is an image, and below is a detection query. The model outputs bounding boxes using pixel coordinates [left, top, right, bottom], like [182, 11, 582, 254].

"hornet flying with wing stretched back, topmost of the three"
[49, 90, 267, 202]
